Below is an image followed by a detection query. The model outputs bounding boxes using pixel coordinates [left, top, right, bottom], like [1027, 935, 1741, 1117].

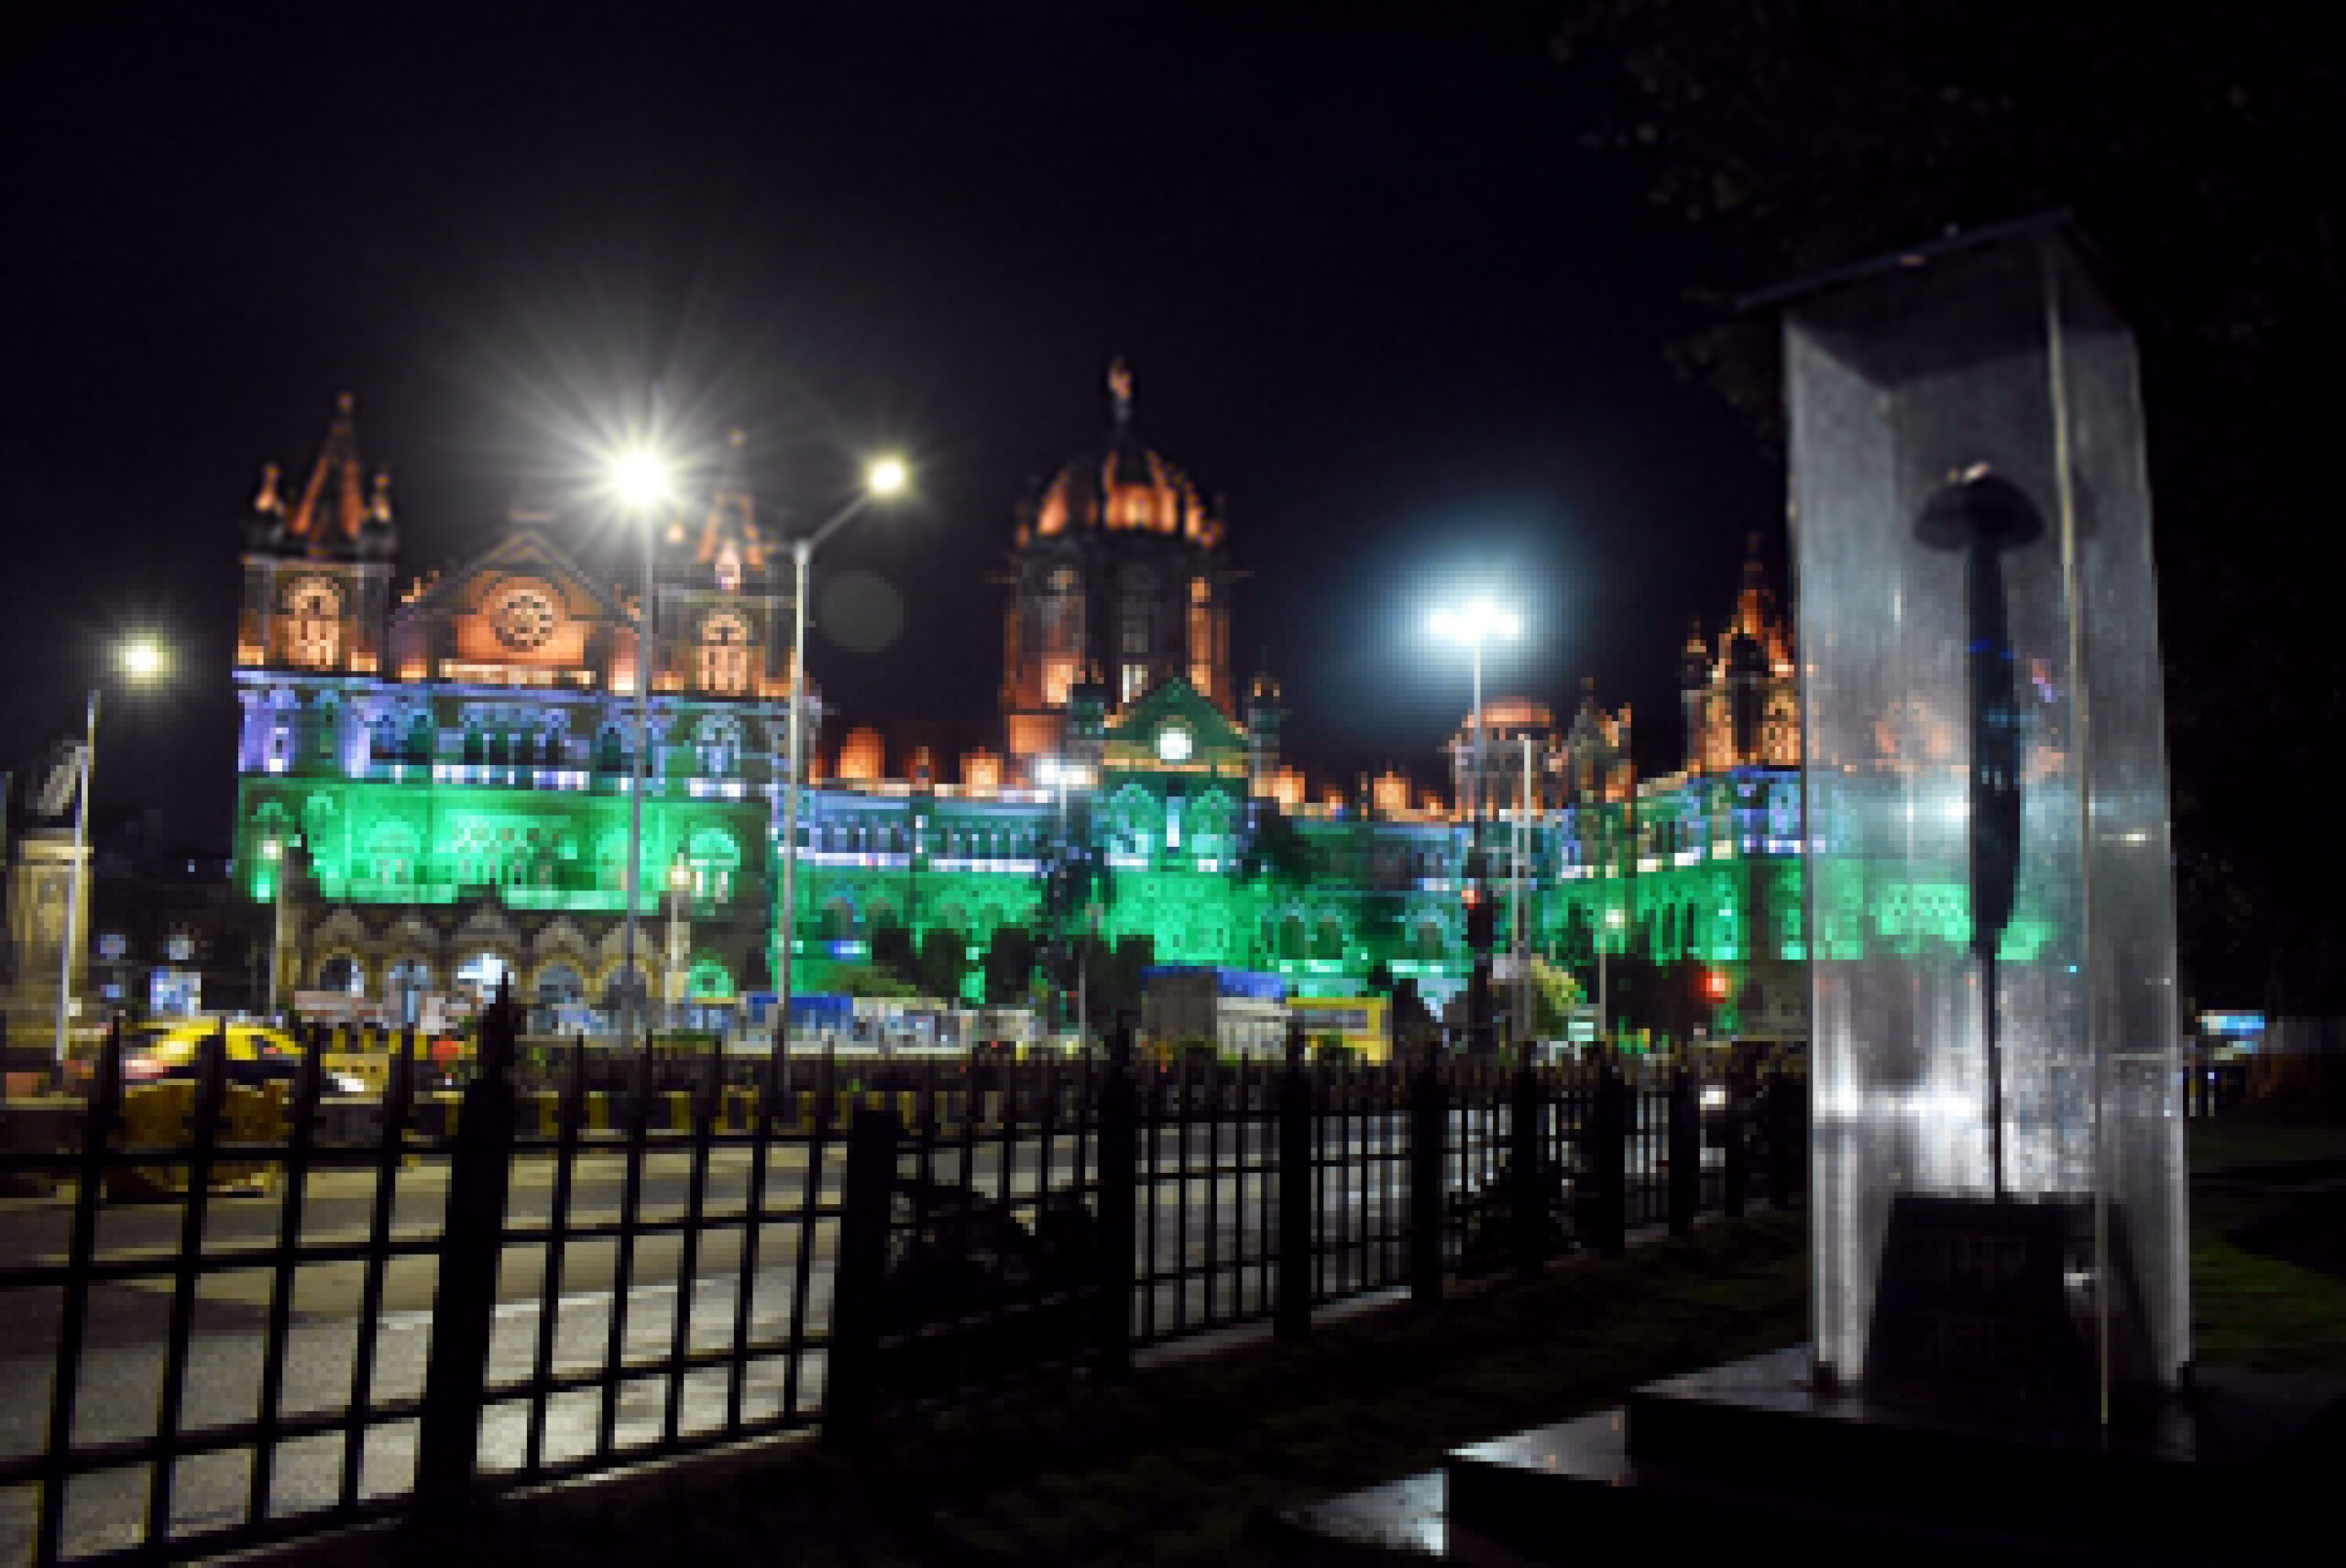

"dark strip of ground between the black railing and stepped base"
[244, 1212, 1806, 1568]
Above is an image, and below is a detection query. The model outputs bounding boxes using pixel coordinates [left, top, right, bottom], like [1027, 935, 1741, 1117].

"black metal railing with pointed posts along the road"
[0, 1009, 1806, 1563]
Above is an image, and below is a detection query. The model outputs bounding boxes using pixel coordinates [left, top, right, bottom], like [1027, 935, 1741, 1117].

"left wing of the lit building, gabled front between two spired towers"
[235, 397, 788, 1014]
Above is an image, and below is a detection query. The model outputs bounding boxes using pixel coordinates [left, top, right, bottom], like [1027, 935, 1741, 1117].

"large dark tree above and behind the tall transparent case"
[1558, 0, 2346, 1012]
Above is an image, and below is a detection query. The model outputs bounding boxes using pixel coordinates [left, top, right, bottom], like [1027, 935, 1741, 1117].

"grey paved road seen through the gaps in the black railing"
[0, 1120, 1689, 1559]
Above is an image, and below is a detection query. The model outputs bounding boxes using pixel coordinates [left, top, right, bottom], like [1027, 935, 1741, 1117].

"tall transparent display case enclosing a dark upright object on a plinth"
[1783, 221, 2191, 1422]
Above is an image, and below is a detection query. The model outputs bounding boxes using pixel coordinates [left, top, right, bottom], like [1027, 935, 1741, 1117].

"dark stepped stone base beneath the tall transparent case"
[1445, 1345, 2346, 1568]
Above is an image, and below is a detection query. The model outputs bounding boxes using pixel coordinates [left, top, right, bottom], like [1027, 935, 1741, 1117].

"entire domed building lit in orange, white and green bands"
[235, 367, 2034, 1037]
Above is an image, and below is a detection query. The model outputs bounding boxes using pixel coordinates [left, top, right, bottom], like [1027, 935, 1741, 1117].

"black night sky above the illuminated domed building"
[0, 3, 1783, 843]
